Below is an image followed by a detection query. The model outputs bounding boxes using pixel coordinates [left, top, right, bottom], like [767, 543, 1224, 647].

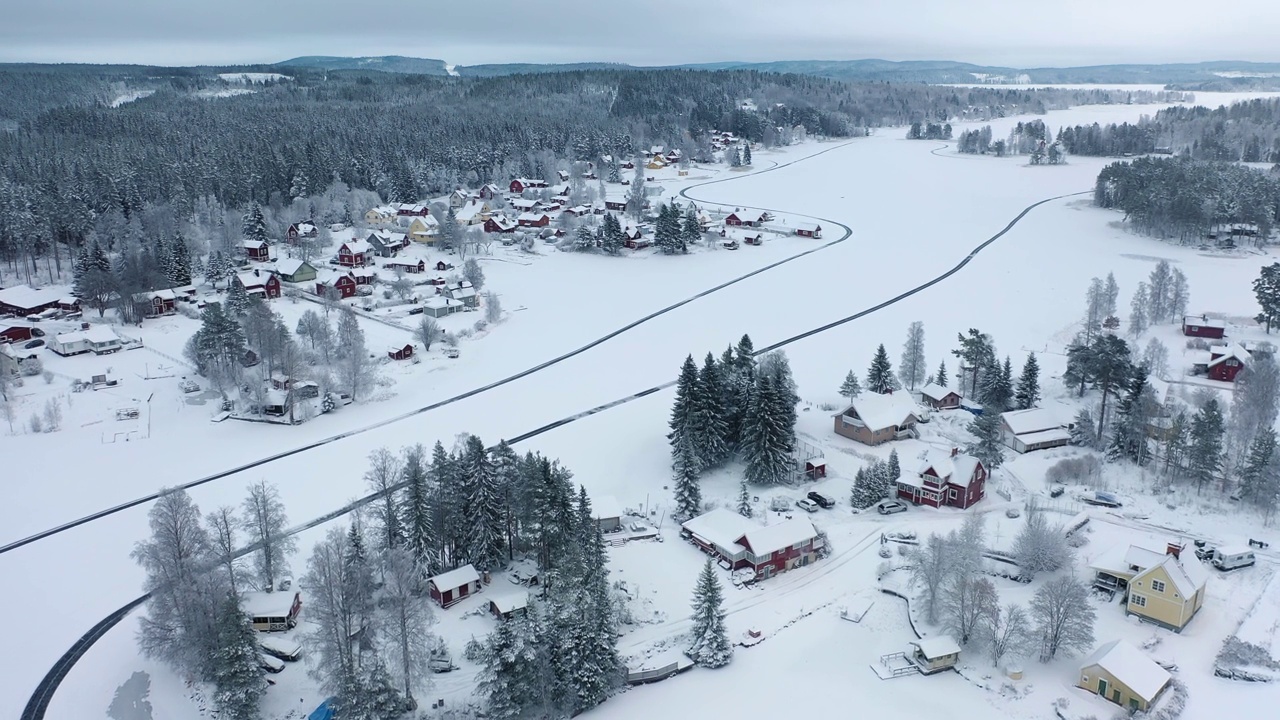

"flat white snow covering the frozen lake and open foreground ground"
[10, 87, 1280, 719]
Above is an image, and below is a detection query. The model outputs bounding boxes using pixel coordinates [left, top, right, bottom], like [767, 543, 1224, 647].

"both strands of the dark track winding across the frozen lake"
[20, 137, 1091, 720]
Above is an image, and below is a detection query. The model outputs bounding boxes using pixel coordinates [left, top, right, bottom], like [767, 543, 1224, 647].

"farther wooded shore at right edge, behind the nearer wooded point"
[1059, 99, 1280, 163]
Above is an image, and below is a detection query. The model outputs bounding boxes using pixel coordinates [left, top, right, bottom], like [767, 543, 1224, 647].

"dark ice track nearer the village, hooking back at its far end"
[0, 142, 854, 555]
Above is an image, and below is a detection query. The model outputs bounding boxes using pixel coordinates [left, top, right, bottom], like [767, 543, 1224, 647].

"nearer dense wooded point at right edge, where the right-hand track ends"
[1093, 158, 1280, 243]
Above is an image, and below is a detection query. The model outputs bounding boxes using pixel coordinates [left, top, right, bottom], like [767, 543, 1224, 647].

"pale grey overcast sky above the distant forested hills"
[0, 0, 1280, 68]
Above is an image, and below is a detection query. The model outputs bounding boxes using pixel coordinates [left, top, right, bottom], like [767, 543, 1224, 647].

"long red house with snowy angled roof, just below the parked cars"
[681, 507, 823, 579]
